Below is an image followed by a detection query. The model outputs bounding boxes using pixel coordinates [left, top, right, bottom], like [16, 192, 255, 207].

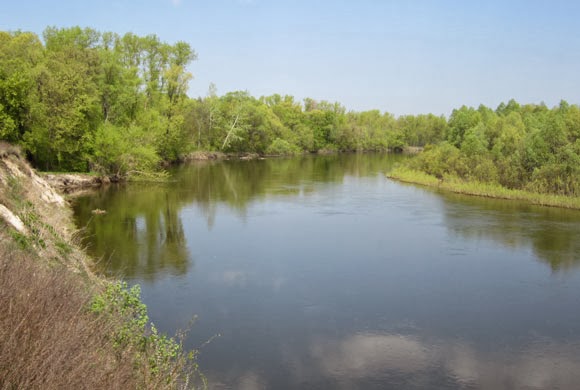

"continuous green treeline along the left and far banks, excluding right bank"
[0, 27, 446, 174]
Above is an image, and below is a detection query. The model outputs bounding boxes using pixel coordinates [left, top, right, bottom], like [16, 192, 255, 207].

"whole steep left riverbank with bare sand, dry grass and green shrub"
[0, 145, 204, 389]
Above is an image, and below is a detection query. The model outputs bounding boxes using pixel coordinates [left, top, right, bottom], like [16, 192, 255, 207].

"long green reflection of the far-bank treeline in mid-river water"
[175, 154, 401, 219]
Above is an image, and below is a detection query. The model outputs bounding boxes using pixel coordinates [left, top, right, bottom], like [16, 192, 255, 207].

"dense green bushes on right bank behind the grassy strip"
[411, 100, 580, 196]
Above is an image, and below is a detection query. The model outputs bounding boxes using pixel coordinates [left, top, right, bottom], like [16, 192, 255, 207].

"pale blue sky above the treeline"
[0, 0, 580, 115]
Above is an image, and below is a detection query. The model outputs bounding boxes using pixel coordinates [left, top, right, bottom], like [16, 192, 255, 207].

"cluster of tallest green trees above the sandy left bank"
[0, 27, 195, 173]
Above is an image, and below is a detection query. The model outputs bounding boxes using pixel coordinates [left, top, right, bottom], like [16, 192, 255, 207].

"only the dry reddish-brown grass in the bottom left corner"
[0, 239, 135, 389]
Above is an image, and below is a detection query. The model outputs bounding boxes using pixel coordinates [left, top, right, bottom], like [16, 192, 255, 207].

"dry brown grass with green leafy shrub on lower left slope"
[0, 236, 203, 389]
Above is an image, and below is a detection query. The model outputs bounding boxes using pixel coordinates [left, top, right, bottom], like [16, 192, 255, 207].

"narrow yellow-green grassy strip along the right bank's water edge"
[387, 167, 580, 210]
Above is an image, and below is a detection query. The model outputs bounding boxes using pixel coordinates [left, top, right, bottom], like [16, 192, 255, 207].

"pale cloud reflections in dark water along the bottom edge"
[208, 333, 580, 390]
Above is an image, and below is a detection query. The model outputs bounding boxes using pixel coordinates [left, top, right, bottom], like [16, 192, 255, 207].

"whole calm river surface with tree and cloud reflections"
[75, 155, 580, 389]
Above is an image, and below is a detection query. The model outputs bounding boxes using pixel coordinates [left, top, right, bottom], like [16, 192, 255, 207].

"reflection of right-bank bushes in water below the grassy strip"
[443, 194, 580, 271]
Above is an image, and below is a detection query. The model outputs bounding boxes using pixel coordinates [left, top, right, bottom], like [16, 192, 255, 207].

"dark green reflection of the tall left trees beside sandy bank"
[75, 185, 190, 280]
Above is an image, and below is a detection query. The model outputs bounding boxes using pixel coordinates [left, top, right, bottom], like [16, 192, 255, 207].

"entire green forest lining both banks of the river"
[0, 27, 580, 196]
